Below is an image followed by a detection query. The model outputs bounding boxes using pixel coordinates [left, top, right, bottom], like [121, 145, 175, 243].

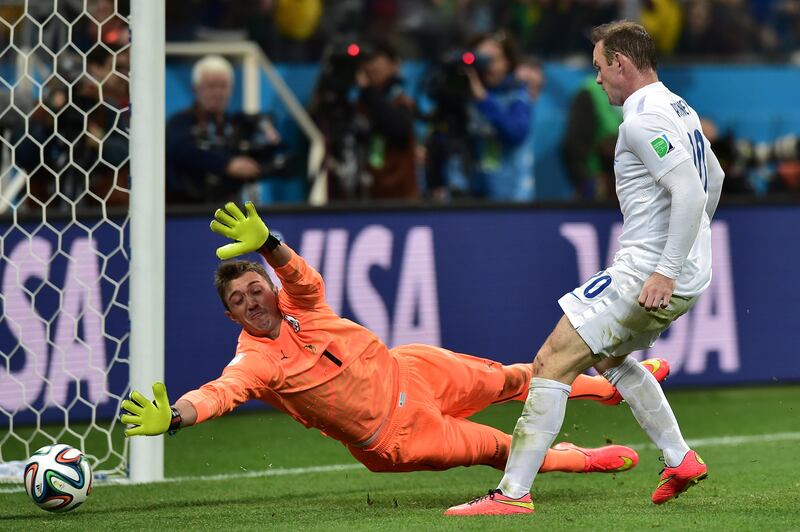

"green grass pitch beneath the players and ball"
[0, 386, 800, 532]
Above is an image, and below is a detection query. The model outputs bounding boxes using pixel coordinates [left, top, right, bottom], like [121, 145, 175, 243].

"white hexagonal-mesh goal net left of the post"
[0, 0, 162, 482]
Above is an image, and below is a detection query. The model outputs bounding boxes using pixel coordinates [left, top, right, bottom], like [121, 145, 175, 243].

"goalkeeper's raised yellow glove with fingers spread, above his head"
[211, 201, 269, 260]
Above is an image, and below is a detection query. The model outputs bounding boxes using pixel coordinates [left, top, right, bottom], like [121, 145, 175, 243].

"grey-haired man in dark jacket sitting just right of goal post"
[166, 55, 281, 203]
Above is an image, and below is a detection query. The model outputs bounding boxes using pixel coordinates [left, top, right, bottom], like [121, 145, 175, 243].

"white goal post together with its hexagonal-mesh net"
[0, 0, 165, 483]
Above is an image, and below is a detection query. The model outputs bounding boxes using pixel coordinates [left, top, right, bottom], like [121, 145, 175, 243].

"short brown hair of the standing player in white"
[591, 20, 658, 71]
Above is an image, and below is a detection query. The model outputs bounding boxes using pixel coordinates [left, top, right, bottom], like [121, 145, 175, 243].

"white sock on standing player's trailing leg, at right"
[603, 357, 689, 467]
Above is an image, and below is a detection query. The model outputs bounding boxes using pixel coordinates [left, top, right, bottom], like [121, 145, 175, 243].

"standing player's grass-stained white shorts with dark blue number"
[558, 262, 697, 357]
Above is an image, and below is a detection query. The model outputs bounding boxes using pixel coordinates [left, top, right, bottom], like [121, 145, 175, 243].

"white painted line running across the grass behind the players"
[0, 432, 800, 493]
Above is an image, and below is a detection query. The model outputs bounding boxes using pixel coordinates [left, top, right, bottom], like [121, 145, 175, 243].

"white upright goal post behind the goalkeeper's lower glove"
[129, 0, 165, 482]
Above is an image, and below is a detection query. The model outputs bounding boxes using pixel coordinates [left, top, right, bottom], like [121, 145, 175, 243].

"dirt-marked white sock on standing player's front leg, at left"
[497, 377, 572, 499]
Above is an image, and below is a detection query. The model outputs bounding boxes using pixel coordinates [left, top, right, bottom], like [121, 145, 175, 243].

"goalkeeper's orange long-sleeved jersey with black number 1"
[181, 251, 398, 444]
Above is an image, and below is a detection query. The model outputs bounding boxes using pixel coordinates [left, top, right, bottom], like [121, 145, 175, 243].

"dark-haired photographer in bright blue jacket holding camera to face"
[466, 32, 535, 201]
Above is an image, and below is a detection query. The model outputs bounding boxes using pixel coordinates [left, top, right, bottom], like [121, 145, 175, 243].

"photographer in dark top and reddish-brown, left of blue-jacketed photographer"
[355, 41, 419, 199]
